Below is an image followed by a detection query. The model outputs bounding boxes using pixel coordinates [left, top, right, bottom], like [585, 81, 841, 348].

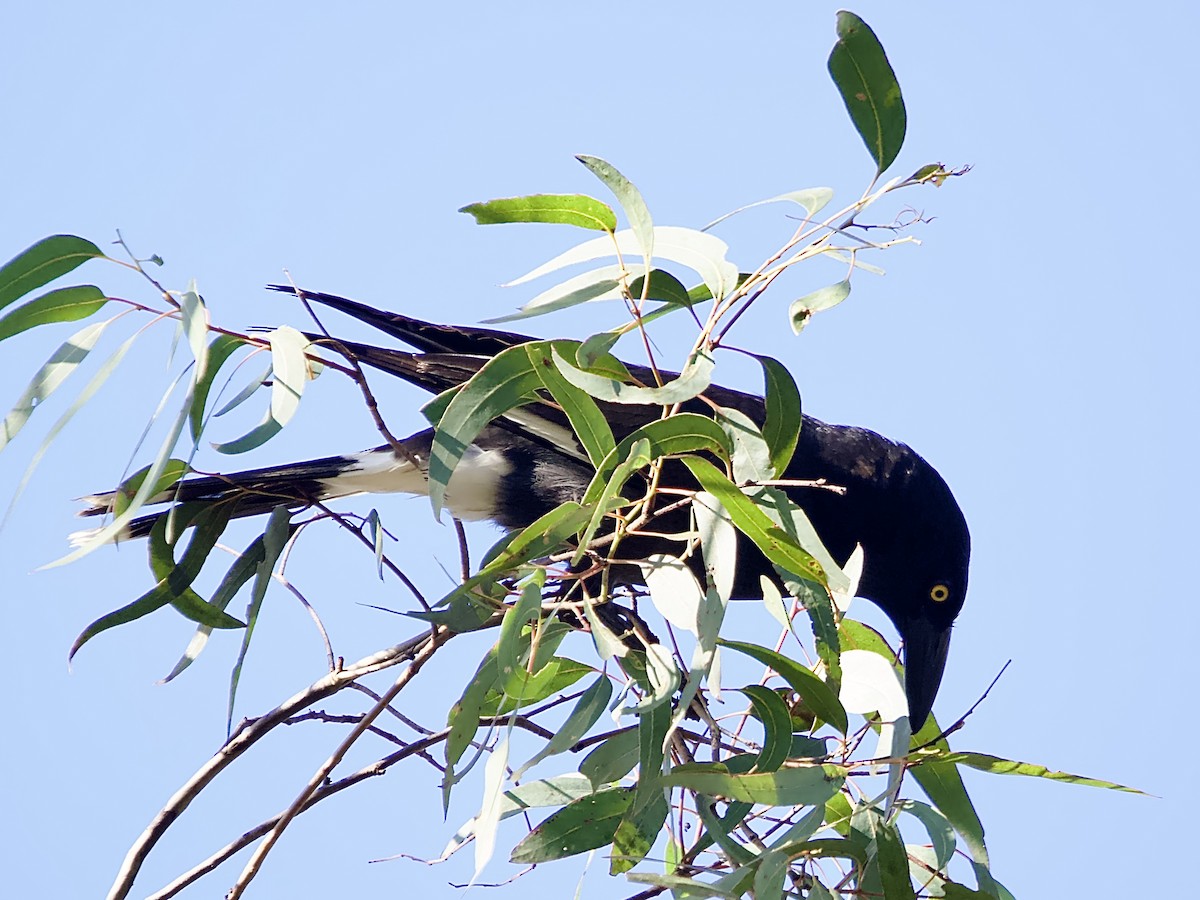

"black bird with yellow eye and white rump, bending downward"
[80, 292, 971, 731]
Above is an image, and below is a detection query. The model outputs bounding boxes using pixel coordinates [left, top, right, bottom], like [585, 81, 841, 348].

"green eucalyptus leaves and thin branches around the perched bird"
[0, 12, 1116, 900]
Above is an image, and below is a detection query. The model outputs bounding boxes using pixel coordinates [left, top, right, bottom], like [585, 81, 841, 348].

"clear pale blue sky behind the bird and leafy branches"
[0, 0, 1200, 898]
